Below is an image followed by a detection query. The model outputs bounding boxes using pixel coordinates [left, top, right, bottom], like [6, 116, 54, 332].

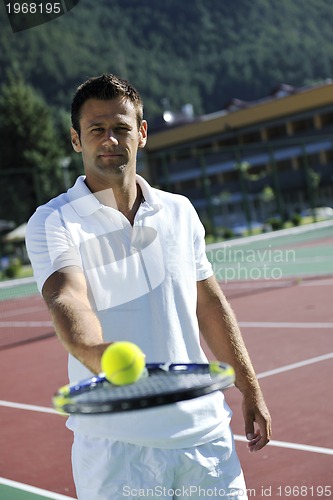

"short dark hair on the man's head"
[71, 73, 143, 135]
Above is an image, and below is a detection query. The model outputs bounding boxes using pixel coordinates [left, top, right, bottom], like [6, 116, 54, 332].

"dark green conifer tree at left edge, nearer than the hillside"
[0, 72, 64, 224]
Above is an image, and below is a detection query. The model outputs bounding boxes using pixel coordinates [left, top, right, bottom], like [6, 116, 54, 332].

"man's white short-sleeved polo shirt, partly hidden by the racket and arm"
[26, 176, 231, 448]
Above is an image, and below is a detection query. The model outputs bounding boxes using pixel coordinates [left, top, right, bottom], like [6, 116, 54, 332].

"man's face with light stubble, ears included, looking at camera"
[71, 98, 147, 187]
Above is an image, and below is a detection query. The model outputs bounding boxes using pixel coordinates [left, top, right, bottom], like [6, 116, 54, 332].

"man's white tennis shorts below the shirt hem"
[72, 431, 247, 500]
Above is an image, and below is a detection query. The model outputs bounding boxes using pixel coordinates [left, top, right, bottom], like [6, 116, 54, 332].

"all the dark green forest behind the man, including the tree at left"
[0, 0, 333, 223]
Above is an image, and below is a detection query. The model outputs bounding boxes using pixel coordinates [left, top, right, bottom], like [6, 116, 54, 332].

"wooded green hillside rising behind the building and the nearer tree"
[0, 0, 333, 118]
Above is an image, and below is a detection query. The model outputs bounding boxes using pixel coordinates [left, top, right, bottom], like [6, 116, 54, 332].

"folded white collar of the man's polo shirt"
[67, 175, 162, 217]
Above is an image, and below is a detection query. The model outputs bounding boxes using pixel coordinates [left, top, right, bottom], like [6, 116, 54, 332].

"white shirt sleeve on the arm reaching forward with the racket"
[26, 206, 82, 292]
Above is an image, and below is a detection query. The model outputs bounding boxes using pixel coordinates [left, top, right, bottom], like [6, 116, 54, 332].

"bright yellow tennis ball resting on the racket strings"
[101, 341, 146, 385]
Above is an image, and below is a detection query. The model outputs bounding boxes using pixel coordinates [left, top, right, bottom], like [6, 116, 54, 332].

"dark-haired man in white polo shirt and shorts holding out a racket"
[27, 75, 271, 500]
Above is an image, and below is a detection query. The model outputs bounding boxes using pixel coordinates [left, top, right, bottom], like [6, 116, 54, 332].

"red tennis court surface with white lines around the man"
[0, 229, 333, 500]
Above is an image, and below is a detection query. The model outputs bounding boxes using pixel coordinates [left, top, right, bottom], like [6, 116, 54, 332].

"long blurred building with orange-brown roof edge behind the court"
[145, 80, 333, 232]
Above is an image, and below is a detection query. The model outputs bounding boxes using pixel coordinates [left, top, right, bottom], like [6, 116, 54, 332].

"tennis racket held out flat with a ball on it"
[53, 362, 235, 415]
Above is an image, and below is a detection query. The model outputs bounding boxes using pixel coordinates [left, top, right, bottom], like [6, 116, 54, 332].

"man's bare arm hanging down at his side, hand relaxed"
[197, 276, 271, 451]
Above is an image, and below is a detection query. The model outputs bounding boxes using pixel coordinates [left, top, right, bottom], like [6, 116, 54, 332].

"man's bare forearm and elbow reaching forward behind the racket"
[42, 267, 109, 373]
